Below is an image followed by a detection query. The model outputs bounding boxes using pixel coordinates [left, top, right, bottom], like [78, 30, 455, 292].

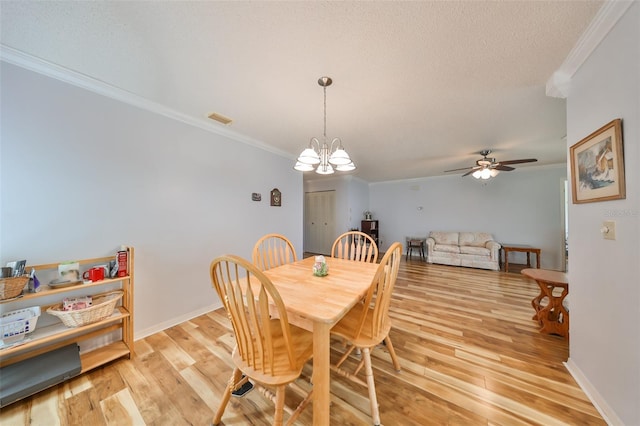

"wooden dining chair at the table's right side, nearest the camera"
[331, 242, 402, 425]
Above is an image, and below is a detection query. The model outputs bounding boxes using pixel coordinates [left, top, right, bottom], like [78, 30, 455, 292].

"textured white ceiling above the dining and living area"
[0, 1, 602, 182]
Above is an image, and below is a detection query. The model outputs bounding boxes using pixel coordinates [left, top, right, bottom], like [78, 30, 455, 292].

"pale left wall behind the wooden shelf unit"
[0, 62, 303, 337]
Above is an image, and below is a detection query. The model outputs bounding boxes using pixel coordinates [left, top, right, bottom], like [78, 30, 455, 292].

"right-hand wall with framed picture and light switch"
[567, 2, 640, 425]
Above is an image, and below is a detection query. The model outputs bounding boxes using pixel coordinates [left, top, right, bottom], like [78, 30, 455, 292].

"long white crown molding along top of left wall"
[0, 43, 295, 160]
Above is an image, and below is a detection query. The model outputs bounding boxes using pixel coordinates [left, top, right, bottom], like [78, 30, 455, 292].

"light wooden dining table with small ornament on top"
[264, 257, 378, 426]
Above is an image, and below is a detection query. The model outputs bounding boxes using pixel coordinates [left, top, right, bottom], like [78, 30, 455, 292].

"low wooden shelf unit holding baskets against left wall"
[0, 247, 134, 373]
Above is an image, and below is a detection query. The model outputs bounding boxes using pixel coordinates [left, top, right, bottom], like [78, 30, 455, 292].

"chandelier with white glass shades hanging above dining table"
[293, 77, 356, 175]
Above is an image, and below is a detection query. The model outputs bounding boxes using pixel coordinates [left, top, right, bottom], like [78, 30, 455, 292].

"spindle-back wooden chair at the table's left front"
[211, 255, 313, 425]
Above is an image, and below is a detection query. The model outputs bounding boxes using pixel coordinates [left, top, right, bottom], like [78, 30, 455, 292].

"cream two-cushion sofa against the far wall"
[427, 232, 501, 271]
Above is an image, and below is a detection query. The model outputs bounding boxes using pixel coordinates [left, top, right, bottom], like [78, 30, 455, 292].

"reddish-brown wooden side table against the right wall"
[521, 268, 569, 337]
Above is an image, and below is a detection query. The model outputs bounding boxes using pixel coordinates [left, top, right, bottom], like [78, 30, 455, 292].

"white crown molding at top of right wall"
[546, 0, 634, 99]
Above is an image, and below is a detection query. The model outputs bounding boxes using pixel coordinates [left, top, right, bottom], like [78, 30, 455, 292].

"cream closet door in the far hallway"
[304, 191, 336, 255]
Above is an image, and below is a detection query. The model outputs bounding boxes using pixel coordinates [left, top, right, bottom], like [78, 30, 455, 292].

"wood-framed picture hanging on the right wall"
[570, 118, 626, 204]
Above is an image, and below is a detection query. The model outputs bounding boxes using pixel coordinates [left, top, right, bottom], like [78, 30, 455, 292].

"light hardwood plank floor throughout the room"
[0, 260, 605, 426]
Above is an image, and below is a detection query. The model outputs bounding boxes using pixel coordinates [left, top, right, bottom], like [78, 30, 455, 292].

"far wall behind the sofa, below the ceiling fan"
[370, 165, 566, 270]
